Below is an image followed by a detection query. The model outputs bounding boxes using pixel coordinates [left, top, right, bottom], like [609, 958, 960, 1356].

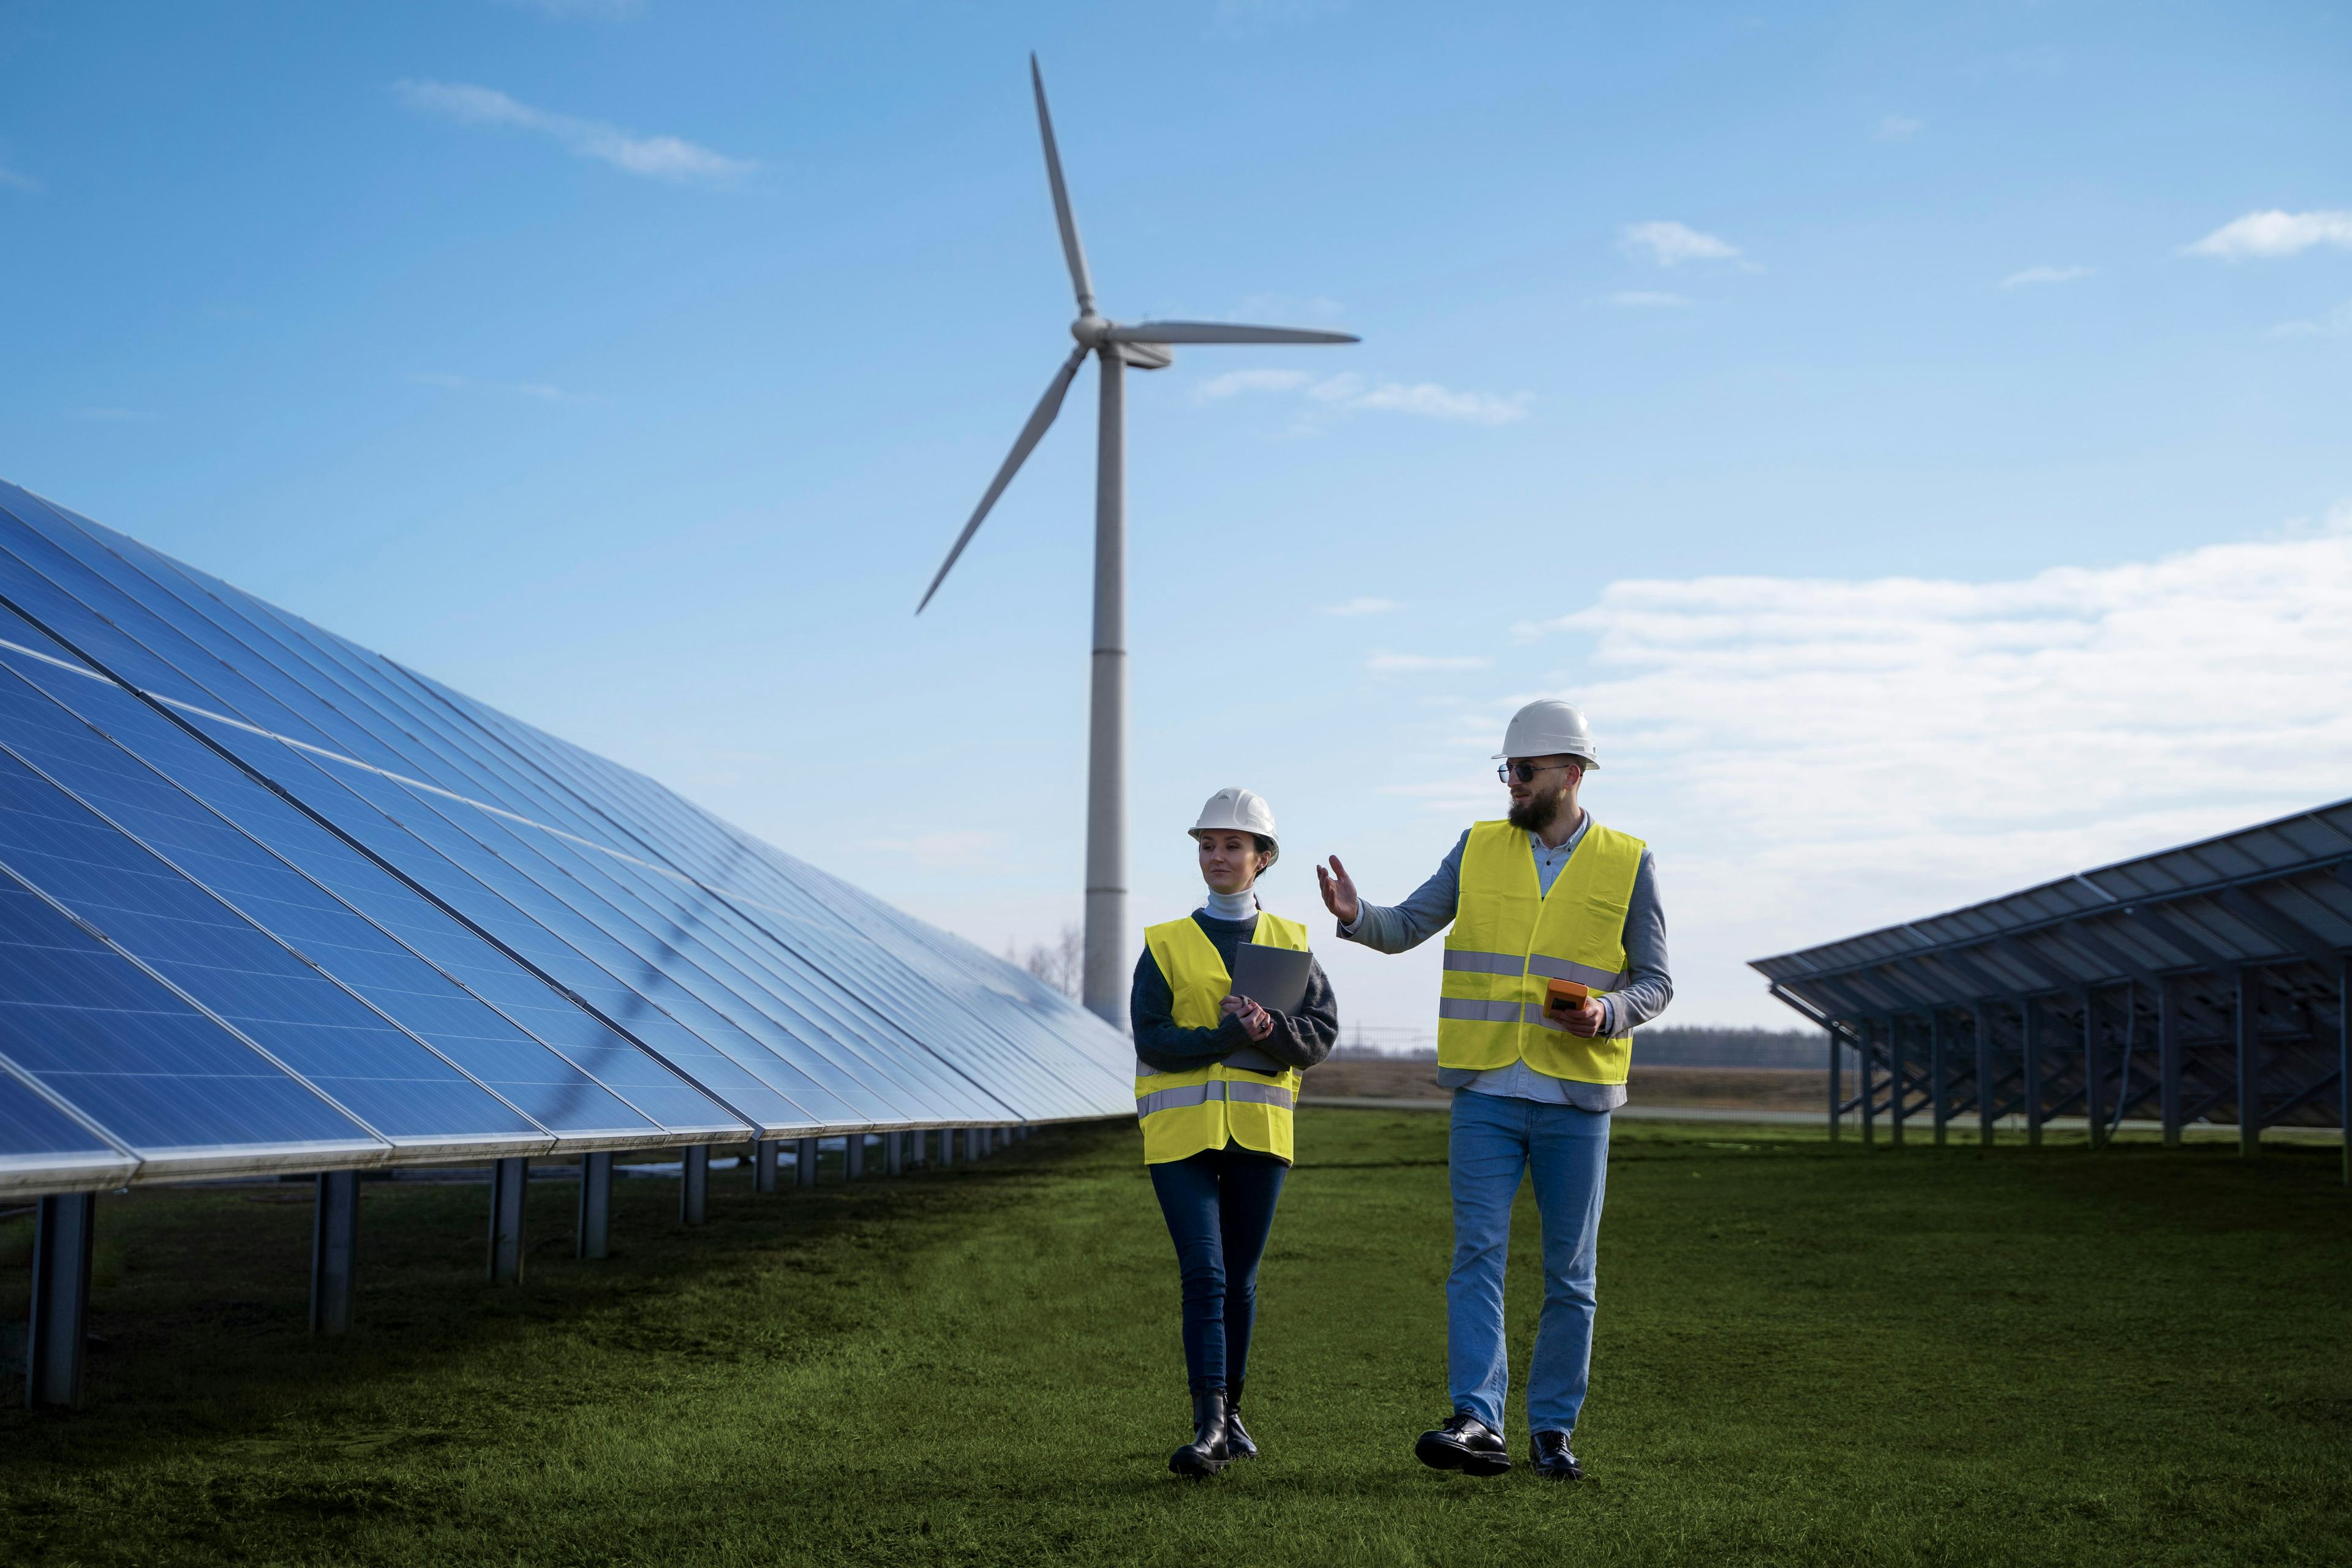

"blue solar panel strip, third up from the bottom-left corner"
[0, 752, 538, 1140]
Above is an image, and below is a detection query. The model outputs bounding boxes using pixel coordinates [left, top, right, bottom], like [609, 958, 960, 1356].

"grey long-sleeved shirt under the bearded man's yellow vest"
[1338, 811, 1675, 1112]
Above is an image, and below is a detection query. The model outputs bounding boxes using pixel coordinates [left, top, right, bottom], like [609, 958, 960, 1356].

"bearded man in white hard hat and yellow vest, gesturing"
[1315, 701, 1675, 1481]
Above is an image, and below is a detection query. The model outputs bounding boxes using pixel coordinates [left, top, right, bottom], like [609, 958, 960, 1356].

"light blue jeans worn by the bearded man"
[1447, 1088, 1609, 1431]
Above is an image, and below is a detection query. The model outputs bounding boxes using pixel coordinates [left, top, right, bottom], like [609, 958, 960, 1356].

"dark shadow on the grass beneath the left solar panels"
[0, 1128, 1125, 1479]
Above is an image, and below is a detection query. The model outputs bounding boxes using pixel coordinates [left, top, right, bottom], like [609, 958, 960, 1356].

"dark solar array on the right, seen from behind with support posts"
[1752, 802, 2352, 1142]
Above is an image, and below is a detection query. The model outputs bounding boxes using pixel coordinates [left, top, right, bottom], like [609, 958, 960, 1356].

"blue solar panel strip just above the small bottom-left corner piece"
[0, 879, 372, 1152]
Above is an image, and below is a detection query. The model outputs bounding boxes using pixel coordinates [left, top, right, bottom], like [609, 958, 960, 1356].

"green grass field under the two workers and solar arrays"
[0, 1110, 2352, 1568]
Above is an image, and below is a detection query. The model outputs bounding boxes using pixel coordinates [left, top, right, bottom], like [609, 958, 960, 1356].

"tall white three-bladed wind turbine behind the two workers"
[915, 54, 1357, 1025]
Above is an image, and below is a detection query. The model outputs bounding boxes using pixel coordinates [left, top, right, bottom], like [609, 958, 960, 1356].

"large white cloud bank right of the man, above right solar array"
[1529, 505, 2352, 1016]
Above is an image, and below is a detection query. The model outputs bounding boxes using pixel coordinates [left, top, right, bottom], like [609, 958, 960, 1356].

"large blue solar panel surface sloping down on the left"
[0, 472, 1134, 1192]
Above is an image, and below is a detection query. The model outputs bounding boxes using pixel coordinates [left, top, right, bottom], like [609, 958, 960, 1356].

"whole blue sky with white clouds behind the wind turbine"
[0, 0, 2352, 1041]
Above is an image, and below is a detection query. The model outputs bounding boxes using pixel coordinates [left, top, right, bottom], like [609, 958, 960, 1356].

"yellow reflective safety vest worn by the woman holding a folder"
[1136, 910, 1308, 1166]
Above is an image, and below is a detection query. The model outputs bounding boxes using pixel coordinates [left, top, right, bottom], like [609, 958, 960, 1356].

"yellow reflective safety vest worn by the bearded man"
[1437, 823, 1642, 1084]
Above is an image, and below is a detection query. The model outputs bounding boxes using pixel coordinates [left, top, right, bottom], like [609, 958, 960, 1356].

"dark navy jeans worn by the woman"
[1148, 1142, 1289, 1394]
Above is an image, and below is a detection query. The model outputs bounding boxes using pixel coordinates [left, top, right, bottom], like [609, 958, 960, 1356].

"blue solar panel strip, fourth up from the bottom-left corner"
[0, 649, 656, 1133]
